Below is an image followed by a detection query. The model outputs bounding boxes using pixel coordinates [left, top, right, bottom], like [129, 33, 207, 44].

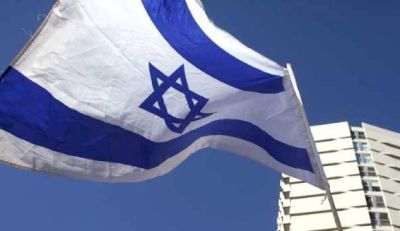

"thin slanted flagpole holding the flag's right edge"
[286, 63, 343, 231]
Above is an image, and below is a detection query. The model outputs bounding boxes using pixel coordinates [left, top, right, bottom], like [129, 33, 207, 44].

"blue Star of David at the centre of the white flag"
[140, 63, 212, 133]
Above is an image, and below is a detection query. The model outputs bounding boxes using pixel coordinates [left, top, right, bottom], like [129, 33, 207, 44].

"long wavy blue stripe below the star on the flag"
[0, 68, 312, 172]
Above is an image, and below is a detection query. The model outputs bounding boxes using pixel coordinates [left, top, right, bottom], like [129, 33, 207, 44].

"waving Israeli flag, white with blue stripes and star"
[0, 0, 323, 187]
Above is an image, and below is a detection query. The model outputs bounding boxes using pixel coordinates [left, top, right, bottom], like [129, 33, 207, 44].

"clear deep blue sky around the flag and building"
[0, 0, 400, 231]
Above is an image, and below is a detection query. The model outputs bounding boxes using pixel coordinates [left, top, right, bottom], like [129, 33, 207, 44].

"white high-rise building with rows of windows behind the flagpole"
[277, 122, 400, 231]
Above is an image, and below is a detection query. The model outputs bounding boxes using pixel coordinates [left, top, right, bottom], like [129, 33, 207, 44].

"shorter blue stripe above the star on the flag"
[142, 0, 284, 93]
